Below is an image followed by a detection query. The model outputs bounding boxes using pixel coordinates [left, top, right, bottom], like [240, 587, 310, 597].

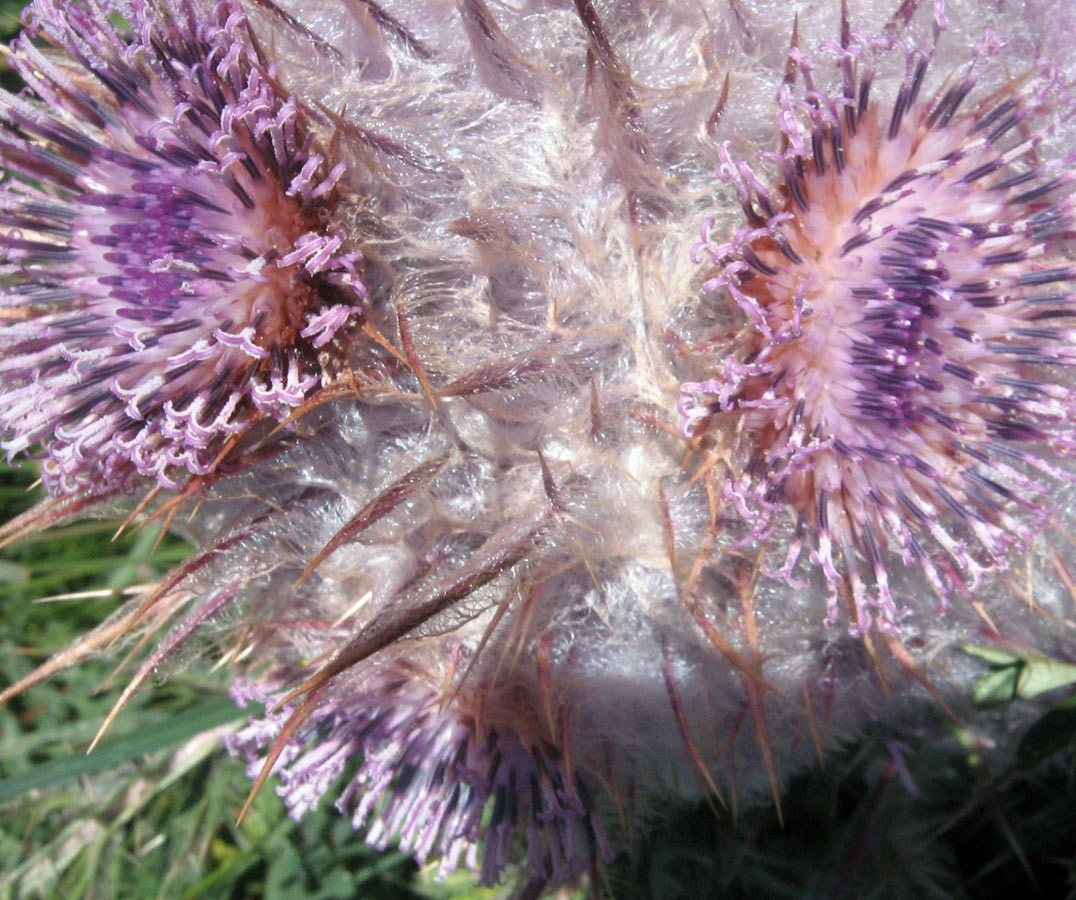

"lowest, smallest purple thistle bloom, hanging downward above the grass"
[225, 673, 610, 884]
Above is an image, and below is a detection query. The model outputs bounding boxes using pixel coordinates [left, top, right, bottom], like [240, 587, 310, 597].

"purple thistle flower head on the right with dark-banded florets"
[680, 24, 1076, 633]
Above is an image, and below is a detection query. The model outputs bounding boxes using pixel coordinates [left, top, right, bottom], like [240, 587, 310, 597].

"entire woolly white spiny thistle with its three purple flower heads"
[0, 0, 1076, 896]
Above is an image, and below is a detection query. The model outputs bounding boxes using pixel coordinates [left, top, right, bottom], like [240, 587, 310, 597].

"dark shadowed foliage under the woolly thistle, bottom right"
[610, 734, 1076, 900]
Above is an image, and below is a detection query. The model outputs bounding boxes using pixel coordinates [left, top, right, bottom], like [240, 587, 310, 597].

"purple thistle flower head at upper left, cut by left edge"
[0, 0, 365, 492]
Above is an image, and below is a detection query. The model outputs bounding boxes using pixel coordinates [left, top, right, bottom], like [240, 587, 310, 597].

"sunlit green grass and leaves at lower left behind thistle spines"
[0, 460, 454, 900]
